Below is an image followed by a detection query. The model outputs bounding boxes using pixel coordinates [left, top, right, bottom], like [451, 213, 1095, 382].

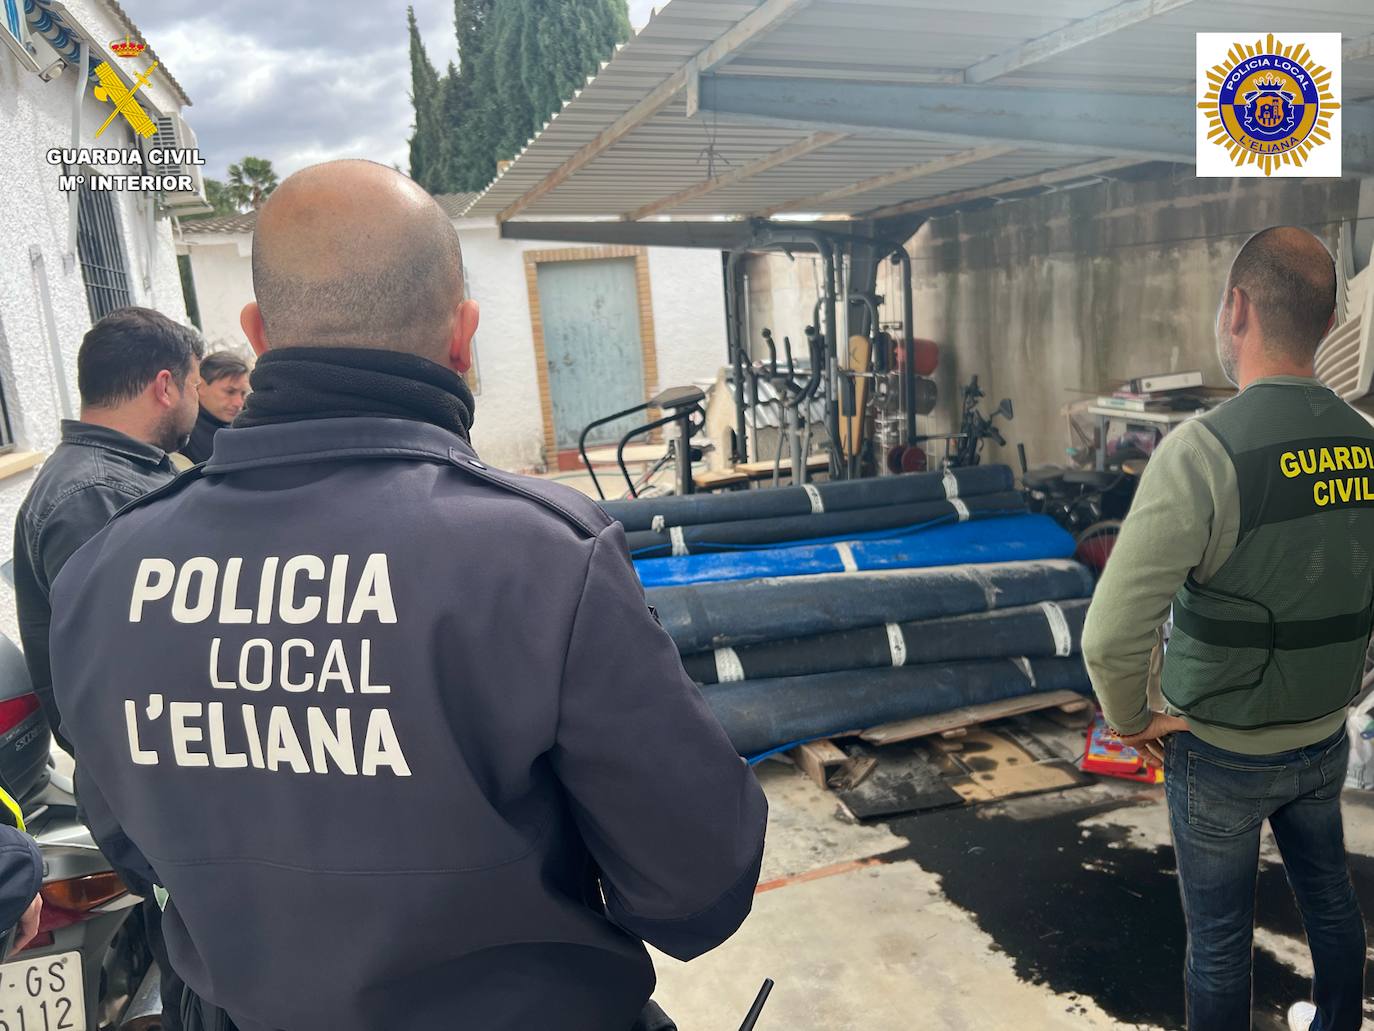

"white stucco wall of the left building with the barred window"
[0, 20, 185, 638]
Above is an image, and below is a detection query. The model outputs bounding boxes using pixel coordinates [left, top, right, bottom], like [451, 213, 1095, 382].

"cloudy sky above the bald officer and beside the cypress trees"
[124, 0, 666, 179]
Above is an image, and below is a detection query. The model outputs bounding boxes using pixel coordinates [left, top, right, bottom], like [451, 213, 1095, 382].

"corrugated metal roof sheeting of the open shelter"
[466, 0, 1374, 225]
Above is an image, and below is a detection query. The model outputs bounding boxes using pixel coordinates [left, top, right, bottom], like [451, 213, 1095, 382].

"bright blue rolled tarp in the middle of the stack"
[635, 514, 1074, 587]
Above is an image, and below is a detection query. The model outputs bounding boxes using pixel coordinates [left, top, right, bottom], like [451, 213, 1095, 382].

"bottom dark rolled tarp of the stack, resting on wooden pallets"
[702, 656, 1091, 756]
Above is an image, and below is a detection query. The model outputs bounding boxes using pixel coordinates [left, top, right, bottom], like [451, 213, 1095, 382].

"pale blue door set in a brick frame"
[537, 258, 647, 451]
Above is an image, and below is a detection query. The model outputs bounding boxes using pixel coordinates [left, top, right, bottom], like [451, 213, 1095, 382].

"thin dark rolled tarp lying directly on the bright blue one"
[625, 491, 1026, 558]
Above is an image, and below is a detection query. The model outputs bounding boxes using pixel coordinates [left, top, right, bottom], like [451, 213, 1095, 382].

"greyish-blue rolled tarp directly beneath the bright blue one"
[646, 559, 1092, 654]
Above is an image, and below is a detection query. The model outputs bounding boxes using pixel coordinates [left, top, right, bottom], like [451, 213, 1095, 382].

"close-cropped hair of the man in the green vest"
[1227, 225, 1336, 362]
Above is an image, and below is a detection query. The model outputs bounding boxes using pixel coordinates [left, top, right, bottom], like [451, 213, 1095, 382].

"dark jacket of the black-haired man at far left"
[14, 419, 176, 751]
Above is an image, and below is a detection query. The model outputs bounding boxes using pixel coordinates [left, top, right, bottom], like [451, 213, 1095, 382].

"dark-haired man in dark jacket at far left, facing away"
[14, 308, 205, 751]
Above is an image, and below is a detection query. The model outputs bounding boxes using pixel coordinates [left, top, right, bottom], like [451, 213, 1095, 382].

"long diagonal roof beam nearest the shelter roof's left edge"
[496, 0, 811, 221]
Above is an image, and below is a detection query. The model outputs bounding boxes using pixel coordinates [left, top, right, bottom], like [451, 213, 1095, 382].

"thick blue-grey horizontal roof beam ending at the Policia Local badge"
[697, 76, 1197, 164]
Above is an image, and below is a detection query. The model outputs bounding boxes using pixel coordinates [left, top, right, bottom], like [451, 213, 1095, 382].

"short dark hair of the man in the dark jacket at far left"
[77, 308, 205, 408]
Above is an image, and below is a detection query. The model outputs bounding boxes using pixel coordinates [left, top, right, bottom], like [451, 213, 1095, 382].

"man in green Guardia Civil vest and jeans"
[1083, 227, 1374, 1031]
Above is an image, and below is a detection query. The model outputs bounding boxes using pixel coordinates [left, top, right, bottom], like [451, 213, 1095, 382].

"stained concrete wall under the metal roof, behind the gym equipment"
[749, 176, 1360, 465]
